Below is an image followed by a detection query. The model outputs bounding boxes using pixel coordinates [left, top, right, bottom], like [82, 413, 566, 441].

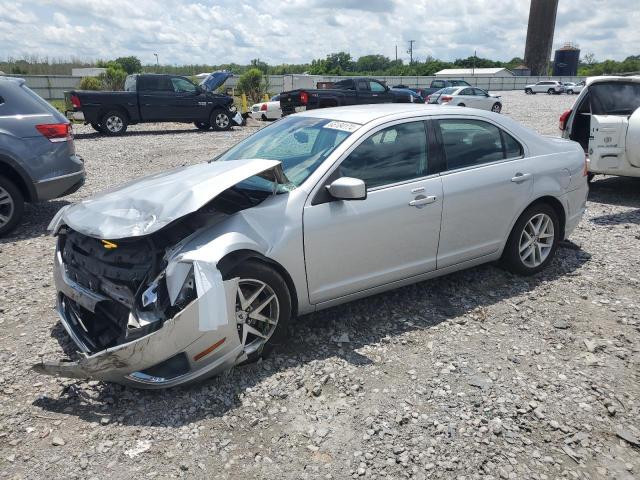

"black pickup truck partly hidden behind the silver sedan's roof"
[280, 77, 413, 116]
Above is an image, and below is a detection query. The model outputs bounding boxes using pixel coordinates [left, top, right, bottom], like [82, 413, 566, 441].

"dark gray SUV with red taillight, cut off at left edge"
[0, 76, 85, 236]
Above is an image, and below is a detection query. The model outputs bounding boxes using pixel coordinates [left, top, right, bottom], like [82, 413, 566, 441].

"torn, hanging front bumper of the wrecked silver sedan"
[33, 251, 246, 388]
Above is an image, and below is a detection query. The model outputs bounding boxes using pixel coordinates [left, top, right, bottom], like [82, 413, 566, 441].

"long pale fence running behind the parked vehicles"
[10, 75, 584, 100]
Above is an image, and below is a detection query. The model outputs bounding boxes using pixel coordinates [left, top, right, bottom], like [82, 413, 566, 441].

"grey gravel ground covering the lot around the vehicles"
[0, 92, 640, 480]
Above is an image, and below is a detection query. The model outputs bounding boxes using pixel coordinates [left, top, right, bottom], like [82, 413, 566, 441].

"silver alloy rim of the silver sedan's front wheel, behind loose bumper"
[236, 278, 280, 355]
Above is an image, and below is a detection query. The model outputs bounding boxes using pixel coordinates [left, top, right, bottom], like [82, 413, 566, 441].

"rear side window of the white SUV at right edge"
[589, 82, 640, 115]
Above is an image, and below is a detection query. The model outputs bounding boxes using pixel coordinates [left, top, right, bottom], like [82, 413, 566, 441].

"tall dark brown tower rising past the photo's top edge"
[524, 0, 558, 75]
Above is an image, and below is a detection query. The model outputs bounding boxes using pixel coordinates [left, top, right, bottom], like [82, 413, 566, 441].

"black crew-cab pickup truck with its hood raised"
[65, 71, 242, 135]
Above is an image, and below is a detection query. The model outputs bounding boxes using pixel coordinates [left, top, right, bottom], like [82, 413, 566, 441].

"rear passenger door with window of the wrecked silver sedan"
[436, 117, 535, 268]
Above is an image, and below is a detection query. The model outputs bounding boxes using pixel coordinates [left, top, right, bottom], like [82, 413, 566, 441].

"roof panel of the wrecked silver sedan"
[296, 103, 496, 125]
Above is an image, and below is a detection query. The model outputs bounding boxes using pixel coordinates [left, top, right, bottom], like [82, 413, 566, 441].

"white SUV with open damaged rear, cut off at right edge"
[560, 76, 640, 178]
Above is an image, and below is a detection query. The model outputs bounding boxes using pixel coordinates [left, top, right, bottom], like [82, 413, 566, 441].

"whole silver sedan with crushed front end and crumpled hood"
[35, 104, 587, 388]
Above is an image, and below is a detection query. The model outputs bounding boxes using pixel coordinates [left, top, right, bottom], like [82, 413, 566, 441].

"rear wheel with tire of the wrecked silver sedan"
[502, 203, 560, 275]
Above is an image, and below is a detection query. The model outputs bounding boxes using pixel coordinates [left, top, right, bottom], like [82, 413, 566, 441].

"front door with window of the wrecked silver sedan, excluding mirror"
[303, 121, 442, 304]
